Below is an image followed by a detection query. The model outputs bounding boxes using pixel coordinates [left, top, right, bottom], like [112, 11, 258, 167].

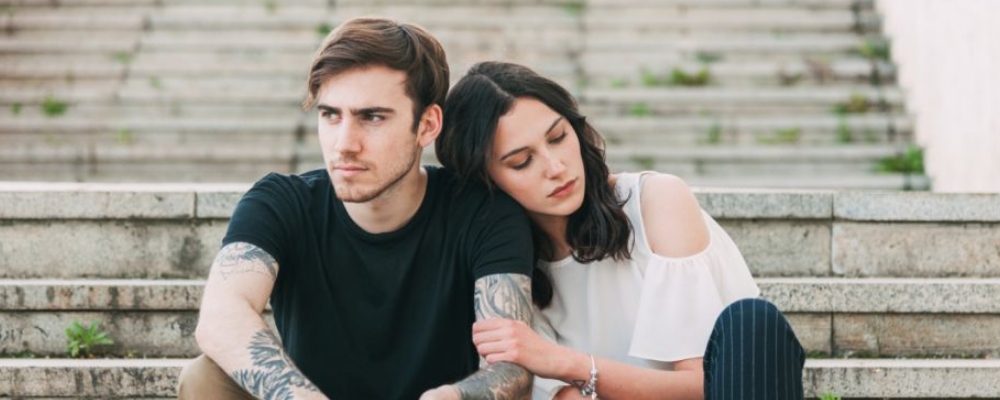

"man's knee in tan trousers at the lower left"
[177, 355, 253, 400]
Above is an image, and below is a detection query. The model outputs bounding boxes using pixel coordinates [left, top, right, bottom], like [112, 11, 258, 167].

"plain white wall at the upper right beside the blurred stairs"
[877, 0, 1000, 192]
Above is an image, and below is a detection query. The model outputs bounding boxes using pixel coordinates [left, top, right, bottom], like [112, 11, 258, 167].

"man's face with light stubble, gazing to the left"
[318, 66, 422, 203]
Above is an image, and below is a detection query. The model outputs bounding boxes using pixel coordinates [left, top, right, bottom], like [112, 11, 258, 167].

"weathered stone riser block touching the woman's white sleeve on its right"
[719, 220, 830, 277]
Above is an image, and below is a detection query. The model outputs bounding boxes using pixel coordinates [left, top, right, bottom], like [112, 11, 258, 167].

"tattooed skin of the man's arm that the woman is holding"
[455, 274, 532, 400]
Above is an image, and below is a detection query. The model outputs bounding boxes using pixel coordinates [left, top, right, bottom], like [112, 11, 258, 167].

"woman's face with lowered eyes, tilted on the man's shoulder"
[486, 97, 586, 217]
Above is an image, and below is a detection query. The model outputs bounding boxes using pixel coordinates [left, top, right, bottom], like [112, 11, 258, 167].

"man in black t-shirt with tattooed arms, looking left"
[178, 18, 532, 400]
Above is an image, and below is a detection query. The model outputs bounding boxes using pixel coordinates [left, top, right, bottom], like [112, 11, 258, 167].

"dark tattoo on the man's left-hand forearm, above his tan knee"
[229, 329, 320, 400]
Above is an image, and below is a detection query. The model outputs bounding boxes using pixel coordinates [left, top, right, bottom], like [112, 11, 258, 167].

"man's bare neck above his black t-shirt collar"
[344, 167, 427, 233]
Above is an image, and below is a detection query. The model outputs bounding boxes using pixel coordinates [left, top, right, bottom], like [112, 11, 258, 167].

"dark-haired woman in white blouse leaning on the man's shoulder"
[436, 62, 804, 400]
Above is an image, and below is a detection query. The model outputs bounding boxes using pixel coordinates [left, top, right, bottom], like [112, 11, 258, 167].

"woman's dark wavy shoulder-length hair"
[435, 62, 632, 308]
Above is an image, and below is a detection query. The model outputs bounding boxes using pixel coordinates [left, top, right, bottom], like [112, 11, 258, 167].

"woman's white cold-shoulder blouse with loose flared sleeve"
[533, 173, 760, 400]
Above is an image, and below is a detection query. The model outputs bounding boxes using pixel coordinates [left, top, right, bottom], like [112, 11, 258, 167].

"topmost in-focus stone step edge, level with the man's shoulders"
[0, 188, 1000, 223]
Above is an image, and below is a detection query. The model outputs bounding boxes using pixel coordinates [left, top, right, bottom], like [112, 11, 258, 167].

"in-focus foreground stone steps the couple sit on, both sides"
[0, 183, 1000, 399]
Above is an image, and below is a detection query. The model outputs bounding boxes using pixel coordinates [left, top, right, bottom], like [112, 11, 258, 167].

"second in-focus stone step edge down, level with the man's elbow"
[0, 278, 1000, 314]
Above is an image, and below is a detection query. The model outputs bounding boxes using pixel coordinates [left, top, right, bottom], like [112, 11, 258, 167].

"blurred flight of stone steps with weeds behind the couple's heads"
[0, 0, 929, 189]
